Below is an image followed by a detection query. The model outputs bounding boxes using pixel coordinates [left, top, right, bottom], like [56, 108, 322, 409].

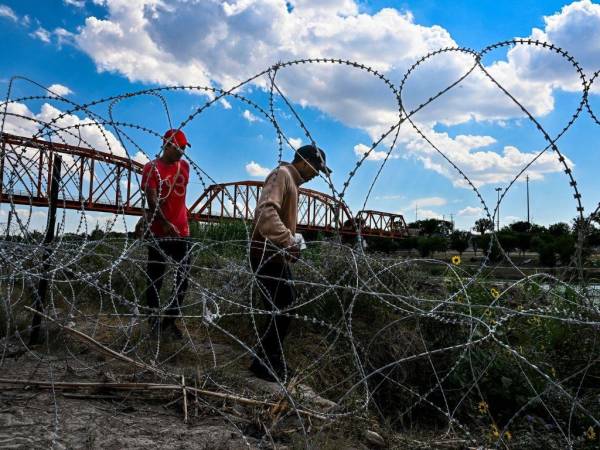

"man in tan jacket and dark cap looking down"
[250, 145, 331, 382]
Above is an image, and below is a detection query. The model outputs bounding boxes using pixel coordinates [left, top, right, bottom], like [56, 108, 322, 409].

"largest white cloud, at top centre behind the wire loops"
[68, 0, 589, 129]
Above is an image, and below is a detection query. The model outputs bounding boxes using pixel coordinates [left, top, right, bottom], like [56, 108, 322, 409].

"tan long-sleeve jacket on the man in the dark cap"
[252, 163, 303, 258]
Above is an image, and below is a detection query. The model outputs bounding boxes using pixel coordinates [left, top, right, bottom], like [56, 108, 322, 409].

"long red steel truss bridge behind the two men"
[0, 133, 408, 238]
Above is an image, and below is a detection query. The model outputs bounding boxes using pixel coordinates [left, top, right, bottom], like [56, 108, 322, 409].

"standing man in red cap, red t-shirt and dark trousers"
[142, 130, 190, 338]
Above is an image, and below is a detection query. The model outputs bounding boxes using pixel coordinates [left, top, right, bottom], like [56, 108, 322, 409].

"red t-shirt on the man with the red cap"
[142, 159, 190, 236]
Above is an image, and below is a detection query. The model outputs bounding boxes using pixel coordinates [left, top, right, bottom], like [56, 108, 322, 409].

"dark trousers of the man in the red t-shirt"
[146, 239, 190, 316]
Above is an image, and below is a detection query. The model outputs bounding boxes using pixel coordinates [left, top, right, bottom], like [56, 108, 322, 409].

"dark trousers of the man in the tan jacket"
[250, 257, 296, 365]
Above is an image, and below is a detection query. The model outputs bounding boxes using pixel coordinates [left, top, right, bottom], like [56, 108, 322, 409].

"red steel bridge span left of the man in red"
[0, 133, 143, 215]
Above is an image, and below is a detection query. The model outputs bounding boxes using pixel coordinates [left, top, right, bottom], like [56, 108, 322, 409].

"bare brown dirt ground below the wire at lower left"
[0, 330, 356, 450]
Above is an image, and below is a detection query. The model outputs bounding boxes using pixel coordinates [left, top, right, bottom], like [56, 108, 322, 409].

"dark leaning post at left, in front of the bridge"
[29, 154, 62, 345]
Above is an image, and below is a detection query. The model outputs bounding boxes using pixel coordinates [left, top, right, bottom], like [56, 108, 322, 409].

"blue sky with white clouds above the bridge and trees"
[0, 0, 600, 232]
